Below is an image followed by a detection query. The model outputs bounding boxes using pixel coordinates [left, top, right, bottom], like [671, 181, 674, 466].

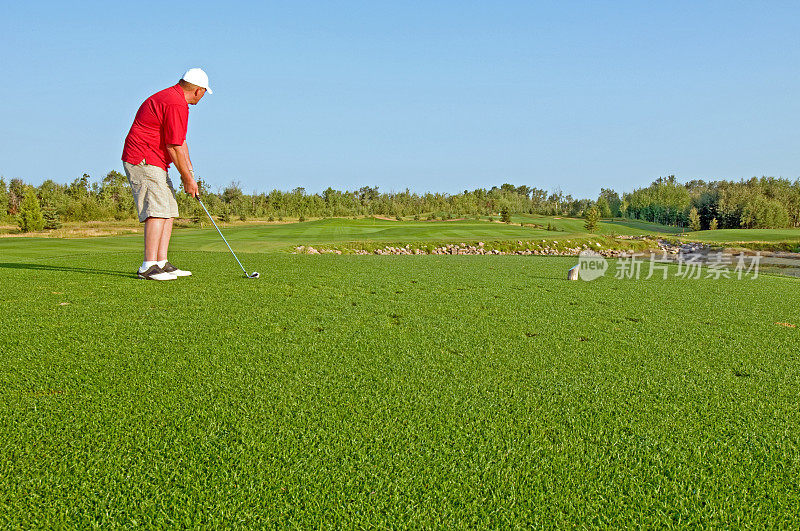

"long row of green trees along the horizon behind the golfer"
[0, 171, 800, 231]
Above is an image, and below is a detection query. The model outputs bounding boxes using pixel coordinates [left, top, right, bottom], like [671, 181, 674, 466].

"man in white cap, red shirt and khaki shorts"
[122, 68, 212, 280]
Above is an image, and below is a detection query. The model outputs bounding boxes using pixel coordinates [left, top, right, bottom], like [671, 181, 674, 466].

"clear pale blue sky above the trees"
[0, 0, 800, 197]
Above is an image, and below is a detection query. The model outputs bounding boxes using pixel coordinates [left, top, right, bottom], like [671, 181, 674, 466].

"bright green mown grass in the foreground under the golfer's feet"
[0, 227, 800, 528]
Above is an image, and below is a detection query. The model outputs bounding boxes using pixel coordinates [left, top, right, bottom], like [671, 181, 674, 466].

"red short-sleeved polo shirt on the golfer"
[122, 84, 189, 171]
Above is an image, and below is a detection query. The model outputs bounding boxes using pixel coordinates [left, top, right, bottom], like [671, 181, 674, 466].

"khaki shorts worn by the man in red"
[122, 160, 178, 223]
